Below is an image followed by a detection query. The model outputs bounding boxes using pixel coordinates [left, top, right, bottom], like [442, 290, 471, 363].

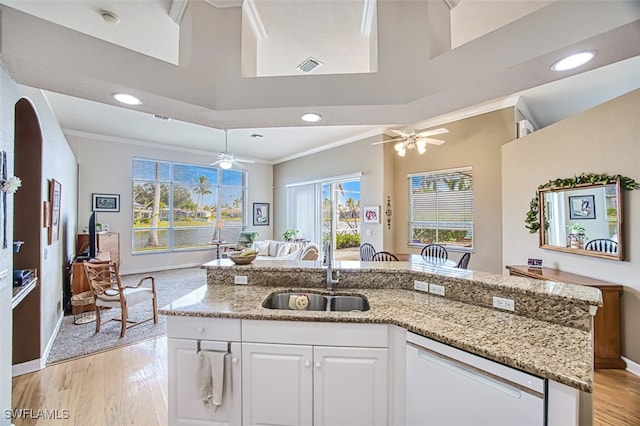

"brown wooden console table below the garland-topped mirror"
[507, 265, 626, 369]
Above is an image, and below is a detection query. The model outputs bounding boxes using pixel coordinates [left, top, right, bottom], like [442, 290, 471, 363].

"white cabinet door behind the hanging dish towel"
[168, 338, 242, 426]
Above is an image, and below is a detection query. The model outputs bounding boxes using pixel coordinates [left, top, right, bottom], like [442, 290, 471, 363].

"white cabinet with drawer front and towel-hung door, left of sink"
[167, 317, 242, 426]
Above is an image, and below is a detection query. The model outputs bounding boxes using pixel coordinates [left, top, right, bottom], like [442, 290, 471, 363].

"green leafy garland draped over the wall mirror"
[524, 173, 640, 234]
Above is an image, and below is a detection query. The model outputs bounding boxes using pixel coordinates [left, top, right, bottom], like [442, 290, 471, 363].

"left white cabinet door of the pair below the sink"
[242, 343, 313, 426]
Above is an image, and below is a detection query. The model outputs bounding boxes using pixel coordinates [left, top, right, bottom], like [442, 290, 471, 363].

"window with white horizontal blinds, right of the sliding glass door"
[408, 167, 473, 251]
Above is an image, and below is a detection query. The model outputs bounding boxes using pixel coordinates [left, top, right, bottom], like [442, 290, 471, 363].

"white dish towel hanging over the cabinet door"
[196, 351, 229, 412]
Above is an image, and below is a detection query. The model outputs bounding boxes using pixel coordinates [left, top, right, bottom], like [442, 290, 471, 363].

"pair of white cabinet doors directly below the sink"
[242, 343, 388, 426]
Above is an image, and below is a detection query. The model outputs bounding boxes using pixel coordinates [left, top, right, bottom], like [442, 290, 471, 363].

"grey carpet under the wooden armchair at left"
[46, 268, 206, 365]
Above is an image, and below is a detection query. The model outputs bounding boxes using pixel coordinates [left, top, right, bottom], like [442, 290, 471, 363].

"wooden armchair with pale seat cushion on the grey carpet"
[83, 262, 158, 337]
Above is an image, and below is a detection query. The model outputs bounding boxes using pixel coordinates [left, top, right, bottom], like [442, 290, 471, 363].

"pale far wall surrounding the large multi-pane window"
[67, 133, 273, 273]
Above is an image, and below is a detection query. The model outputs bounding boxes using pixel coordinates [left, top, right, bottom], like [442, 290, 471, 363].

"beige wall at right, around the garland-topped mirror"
[502, 90, 640, 363]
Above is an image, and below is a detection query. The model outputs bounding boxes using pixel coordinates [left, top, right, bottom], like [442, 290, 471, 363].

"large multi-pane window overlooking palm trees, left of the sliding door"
[133, 158, 246, 253]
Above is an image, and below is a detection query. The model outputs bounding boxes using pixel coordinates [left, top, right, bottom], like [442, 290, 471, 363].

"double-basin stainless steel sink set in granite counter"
[262, 291, 369, 312]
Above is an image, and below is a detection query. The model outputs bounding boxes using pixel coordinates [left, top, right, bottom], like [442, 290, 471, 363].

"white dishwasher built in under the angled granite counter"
[406, 332, 546, 426]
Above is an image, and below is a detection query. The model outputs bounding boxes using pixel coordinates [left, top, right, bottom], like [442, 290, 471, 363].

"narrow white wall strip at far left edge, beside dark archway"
[0, 63, 18, 425]
